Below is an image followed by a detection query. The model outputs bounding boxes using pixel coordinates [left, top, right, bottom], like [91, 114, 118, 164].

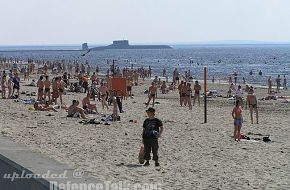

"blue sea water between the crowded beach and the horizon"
[0, 45, 290, 86]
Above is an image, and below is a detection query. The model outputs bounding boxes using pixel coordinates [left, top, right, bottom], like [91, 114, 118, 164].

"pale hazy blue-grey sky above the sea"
[0, 0, 290, 46]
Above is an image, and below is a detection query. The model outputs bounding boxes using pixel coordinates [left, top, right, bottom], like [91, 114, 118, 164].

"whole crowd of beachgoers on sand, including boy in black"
[0, 55, 287, 161]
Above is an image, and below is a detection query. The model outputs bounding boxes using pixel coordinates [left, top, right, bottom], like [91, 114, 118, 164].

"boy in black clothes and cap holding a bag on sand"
[142, 108, 164, 167]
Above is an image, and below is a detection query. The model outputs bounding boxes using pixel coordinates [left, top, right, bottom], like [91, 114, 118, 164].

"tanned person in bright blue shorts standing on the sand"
[232, 100, 243, 141]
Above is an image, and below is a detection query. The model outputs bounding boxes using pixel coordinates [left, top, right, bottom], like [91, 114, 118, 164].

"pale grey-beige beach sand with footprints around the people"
[0, 76, 290, 190]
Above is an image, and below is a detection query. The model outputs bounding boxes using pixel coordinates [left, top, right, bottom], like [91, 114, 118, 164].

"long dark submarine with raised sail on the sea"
[82, 40, 173, 51]
